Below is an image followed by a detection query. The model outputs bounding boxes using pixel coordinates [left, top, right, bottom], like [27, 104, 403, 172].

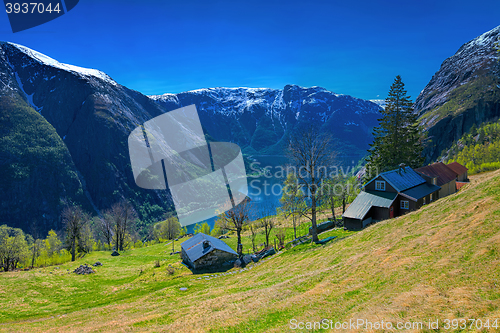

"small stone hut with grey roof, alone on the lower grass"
[181, 233, 238, 270]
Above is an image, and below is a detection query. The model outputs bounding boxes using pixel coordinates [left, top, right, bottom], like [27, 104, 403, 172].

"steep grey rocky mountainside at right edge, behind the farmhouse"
[415, 26, 500, 161]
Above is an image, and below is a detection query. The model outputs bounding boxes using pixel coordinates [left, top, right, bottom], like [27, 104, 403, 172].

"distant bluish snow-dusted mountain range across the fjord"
[150, 85, 379, 155]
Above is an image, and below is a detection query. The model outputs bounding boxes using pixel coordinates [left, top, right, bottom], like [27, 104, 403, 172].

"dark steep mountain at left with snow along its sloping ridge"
[0, 43, 170, 233]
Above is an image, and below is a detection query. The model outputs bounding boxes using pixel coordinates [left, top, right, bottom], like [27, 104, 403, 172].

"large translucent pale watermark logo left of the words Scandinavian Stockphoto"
[128, 105, 248, 226]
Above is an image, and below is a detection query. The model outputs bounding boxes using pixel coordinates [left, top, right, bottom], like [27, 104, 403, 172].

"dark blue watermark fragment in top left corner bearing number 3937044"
[4, 0, 79, 33]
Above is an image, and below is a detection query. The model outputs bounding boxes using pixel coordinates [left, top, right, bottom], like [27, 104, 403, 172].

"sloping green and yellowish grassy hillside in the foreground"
[0, 171, 500, 332]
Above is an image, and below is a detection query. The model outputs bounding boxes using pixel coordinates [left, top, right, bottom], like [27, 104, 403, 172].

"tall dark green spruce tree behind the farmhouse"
[367, 75, 423, 174]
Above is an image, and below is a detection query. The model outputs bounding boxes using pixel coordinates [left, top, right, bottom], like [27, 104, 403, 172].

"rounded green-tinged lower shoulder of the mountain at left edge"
[0, 93, 91, 234]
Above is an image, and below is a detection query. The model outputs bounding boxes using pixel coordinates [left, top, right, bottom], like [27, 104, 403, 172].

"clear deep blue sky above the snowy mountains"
[0, 0, 500, 99]
